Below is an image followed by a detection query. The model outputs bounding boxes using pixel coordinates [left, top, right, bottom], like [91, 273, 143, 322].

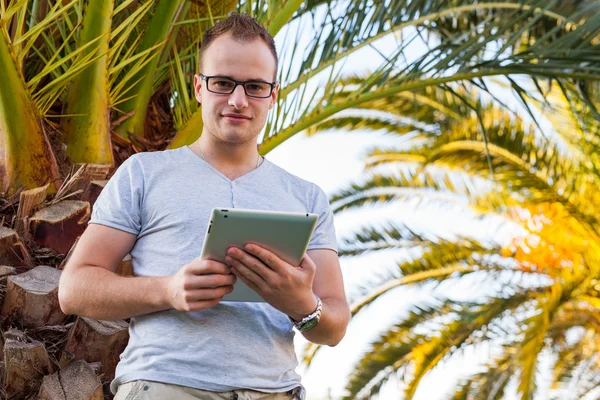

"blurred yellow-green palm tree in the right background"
[305, 77, 600, 399]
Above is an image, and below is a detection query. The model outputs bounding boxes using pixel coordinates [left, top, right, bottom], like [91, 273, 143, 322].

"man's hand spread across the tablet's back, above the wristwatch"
[226, 244, 317, 321]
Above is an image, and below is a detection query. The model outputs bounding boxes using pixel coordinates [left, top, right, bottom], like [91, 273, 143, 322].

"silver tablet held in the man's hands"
[200, 208, 318, 302]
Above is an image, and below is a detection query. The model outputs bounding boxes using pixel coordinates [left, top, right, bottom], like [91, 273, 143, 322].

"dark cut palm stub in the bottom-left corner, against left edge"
[4, 329, 54, 398]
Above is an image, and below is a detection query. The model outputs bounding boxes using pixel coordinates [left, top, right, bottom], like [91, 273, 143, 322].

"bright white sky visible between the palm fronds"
[266, 3, 592, 400]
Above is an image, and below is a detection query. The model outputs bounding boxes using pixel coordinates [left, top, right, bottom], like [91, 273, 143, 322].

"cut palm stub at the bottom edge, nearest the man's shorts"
[38, 360, 104, 400]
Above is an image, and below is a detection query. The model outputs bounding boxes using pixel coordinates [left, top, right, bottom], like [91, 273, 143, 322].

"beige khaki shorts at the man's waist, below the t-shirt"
[114, 380, 304, 400]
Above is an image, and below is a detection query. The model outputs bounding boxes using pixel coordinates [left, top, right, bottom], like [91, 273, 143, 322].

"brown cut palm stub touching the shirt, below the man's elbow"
[59, 317, 129, 380]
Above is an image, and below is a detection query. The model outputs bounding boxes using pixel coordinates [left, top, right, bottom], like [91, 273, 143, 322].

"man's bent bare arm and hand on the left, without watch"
[58, 224, 235, 321]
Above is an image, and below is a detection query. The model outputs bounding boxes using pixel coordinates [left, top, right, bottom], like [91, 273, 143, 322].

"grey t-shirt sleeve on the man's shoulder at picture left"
[88, 155, 144, 235]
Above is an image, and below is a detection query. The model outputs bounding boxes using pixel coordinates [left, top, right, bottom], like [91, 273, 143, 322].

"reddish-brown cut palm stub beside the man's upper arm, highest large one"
[29, 200, 90, 254]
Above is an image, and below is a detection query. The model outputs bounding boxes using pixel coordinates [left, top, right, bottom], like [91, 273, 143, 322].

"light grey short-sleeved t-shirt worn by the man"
[89, 146, 337, 393]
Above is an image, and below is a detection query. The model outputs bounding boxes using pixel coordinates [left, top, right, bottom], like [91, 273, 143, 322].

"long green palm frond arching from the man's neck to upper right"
[261, 0, 598, 152]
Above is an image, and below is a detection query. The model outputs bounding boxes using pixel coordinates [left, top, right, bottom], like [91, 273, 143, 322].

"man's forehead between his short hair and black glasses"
[202, 35, 275, 82]
